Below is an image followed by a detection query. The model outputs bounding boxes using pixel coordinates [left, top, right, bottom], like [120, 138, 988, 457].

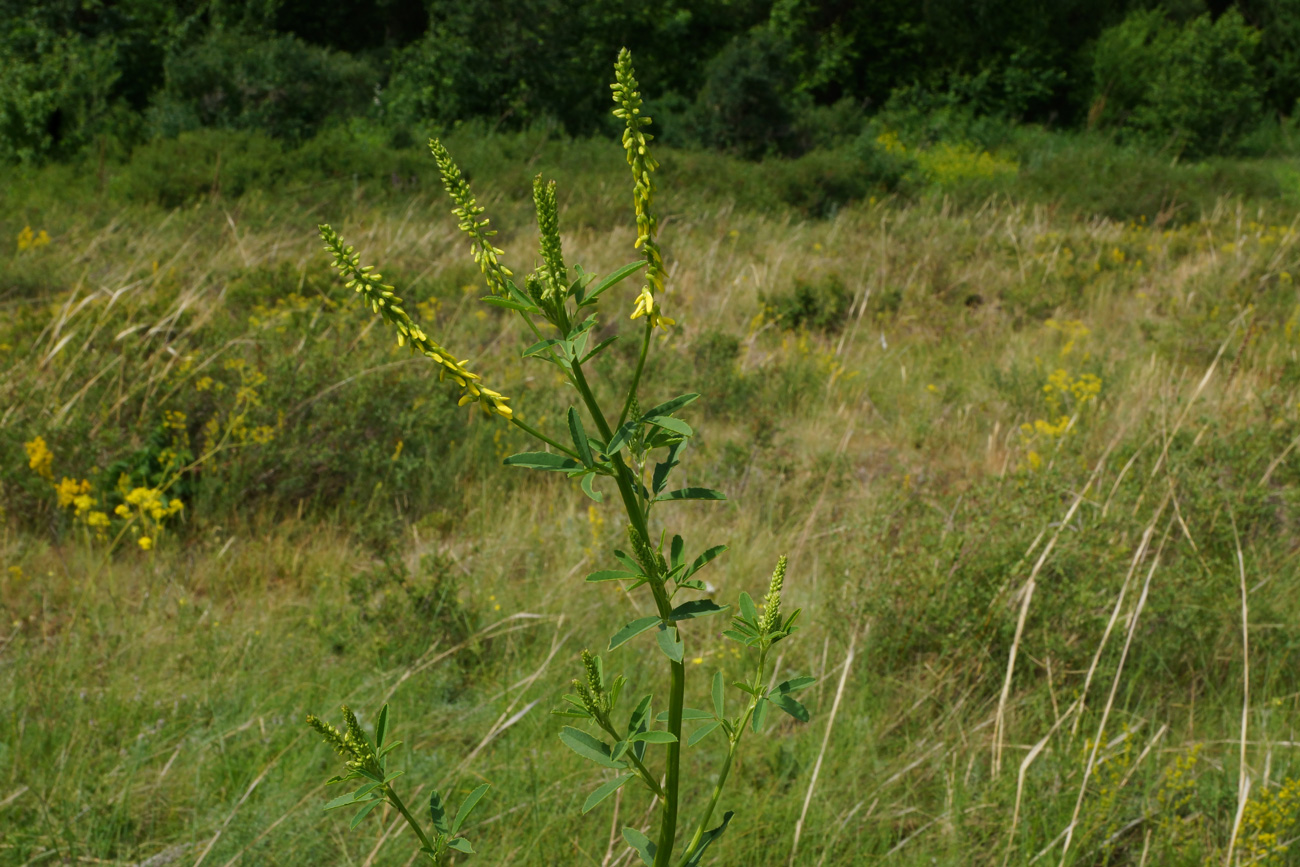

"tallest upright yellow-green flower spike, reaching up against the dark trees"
[610, 48, 676, 328]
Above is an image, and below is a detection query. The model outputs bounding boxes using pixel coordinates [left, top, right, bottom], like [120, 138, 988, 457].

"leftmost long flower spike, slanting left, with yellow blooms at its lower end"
[320, 226, 514, 419]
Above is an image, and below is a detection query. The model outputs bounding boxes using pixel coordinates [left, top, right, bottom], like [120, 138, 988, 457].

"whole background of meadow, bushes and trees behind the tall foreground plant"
[0, 0, 1300, 867]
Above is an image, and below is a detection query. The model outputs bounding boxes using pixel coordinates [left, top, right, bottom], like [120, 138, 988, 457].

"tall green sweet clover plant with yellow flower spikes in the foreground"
[308, 49, 814, 867]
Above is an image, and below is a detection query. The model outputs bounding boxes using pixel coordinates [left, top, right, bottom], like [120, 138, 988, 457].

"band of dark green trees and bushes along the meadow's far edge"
[0, 0, 1300, 162]
